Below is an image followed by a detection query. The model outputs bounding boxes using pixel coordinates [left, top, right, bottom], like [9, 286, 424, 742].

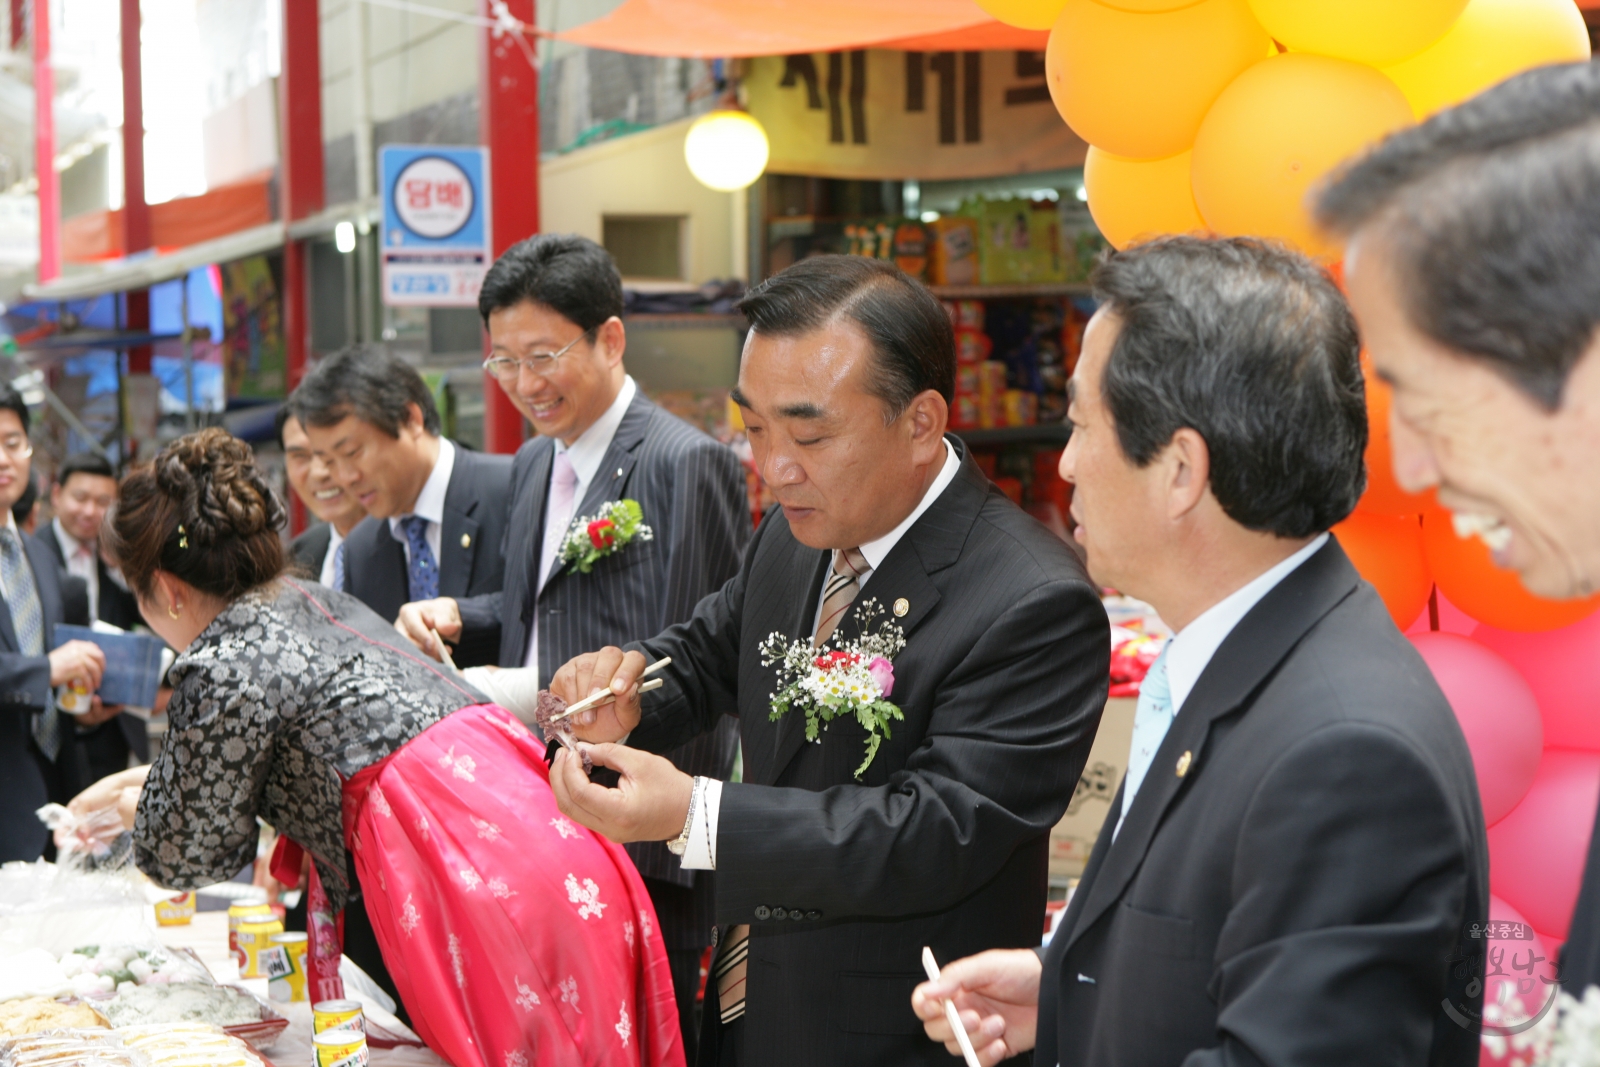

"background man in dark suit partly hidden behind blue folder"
[38, 453, 150, 793]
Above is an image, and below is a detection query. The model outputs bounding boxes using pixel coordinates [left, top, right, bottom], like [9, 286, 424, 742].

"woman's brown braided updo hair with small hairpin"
[110, 427, 285, 601]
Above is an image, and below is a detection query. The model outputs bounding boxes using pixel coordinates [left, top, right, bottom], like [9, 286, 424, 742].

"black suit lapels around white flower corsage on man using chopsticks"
[765, 445, 989, 781]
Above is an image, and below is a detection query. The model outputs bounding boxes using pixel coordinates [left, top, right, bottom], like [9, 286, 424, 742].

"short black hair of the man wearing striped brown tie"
[738, 256, 955, 422]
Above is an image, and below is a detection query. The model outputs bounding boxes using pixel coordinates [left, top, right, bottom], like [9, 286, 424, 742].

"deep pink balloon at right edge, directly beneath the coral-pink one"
[1490, 749, 1600, 941]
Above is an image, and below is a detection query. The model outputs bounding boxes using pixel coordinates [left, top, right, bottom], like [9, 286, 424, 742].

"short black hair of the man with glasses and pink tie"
[478, 234, 622, 333]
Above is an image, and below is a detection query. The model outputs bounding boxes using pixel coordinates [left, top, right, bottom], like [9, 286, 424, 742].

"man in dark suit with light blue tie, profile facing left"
[914, 238, 1488, 1067]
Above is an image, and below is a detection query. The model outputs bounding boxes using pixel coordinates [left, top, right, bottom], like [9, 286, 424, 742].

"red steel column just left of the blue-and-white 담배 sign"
[278, 0, 323, 396]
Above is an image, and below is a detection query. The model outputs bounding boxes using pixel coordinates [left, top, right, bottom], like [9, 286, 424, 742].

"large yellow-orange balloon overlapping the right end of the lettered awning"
[1045, 0, 1272, 160]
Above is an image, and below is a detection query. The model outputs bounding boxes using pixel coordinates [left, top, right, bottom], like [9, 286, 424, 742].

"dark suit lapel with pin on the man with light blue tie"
[1067, 537, 1360, 949]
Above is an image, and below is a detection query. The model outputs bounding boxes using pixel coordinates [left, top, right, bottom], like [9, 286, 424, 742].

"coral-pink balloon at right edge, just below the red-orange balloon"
[1472, 611, 1600, 752]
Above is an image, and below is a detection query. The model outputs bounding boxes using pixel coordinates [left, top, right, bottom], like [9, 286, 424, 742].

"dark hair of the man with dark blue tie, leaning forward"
[291, 344, 440, 442]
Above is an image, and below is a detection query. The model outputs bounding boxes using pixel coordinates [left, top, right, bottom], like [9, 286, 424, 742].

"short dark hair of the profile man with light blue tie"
[1094, 237, 1366, 537]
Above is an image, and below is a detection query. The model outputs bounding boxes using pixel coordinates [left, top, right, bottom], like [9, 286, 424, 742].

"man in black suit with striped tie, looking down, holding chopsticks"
[552, 256, 1109, 1067]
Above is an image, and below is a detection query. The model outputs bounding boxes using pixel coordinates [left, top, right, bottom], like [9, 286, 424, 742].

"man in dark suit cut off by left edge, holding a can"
[0, 386, 117, 862]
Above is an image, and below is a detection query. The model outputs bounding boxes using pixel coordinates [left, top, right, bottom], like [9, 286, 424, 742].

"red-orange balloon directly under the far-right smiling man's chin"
[1422, 507, 1600, 633]
